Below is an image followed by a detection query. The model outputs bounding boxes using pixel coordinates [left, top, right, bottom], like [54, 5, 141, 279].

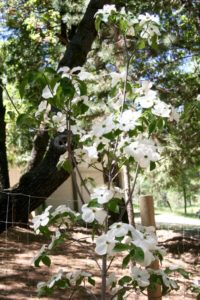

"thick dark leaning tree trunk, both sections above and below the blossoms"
[0, 0, 112, 232]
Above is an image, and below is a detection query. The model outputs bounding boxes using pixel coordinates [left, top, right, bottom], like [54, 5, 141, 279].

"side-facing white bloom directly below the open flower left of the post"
[81, 204, 107, 224]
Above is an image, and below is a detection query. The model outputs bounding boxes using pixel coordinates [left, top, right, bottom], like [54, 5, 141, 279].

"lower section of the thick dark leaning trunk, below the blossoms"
[0, 137, 69, 232]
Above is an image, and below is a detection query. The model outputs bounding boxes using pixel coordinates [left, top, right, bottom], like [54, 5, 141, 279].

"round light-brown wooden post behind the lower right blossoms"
[139, 195, 162, 300]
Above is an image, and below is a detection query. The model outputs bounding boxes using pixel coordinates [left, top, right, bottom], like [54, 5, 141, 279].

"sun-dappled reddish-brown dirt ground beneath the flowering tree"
[0, 227, 200, 300]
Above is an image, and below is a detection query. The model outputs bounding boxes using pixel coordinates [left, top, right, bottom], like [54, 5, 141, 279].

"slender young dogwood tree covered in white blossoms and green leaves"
[32, 5, 191, 300]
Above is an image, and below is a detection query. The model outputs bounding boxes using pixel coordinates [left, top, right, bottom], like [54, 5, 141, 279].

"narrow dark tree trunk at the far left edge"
[0, 78, 10, 191]
